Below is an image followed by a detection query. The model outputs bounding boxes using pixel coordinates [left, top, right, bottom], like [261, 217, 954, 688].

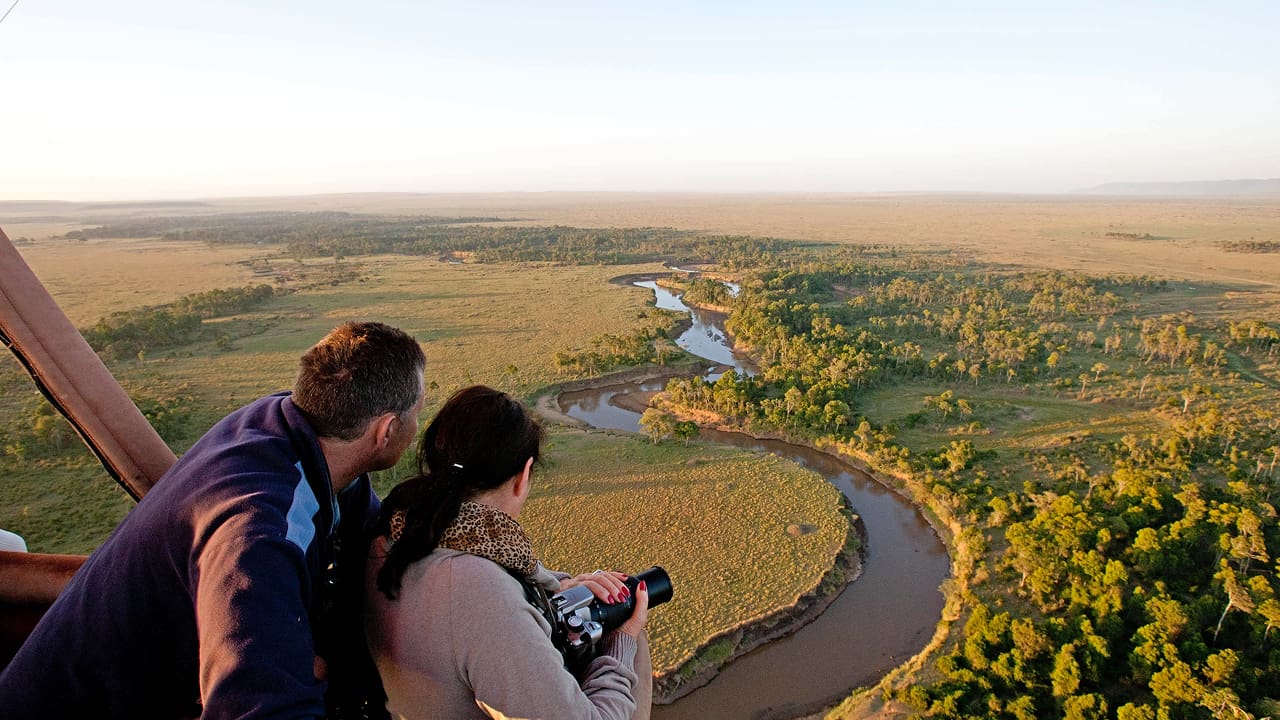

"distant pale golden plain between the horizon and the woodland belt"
[107, 192, 1280, 292]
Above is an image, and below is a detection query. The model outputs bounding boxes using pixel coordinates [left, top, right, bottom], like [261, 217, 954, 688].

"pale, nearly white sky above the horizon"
[0, 0, 1280, 200]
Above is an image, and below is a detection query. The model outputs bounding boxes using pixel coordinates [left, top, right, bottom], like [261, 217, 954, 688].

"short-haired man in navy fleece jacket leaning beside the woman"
[0, 323, 425, 720]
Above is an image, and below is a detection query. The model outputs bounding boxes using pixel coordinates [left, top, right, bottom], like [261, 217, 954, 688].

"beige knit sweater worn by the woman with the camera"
[365, 538, 649, 720]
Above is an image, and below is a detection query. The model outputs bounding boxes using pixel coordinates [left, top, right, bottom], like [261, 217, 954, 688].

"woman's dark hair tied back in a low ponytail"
[376, 386, 543, 600]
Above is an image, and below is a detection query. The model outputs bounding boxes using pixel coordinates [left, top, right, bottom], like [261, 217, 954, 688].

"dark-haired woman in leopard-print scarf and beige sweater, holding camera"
[365, 386, 652, 719]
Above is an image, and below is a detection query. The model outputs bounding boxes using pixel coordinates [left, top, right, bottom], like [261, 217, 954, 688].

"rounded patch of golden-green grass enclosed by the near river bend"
[521, 432, 849, 673]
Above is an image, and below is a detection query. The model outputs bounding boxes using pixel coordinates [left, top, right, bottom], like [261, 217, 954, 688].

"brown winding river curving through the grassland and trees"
[559, 281, 948, 720]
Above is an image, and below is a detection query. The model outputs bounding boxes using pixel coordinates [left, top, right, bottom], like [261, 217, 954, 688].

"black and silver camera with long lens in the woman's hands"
[548, 565, 672, 671]
